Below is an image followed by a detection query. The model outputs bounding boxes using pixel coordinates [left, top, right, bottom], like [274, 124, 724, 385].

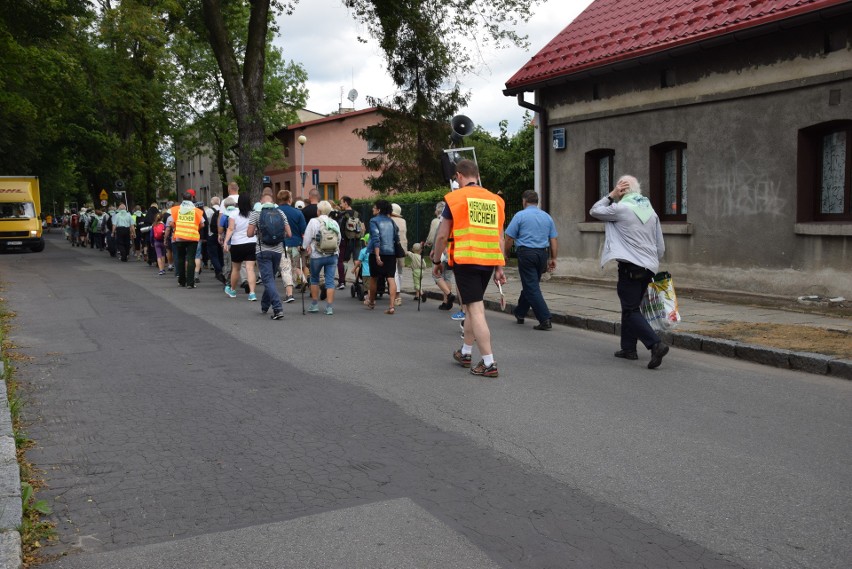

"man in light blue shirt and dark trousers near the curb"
[505, 190, 558, 330]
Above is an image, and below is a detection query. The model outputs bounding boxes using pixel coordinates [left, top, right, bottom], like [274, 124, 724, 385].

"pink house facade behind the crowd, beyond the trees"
[264, 107, 381, 200]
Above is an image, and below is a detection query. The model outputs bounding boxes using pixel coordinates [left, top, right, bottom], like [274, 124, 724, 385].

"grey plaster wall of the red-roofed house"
[539, 16, 852, 298]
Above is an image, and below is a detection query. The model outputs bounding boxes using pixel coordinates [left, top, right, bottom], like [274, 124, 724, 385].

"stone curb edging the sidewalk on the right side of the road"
[422, 291, 852, 380]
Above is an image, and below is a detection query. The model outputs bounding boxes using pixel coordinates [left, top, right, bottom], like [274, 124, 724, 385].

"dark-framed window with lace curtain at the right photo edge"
[797, 121, 852, 222]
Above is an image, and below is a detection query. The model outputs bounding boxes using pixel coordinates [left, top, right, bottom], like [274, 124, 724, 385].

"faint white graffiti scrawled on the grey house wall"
[705, 153, 788, 219]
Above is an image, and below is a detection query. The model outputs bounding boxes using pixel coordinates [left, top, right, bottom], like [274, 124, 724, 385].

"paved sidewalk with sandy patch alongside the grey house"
[402, 267, 852, 379]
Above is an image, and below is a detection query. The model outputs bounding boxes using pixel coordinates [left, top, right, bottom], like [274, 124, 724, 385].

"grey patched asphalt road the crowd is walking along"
[0, 236, 852, 569]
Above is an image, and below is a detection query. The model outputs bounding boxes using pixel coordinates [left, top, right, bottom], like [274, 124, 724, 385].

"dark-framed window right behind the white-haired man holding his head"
[649, 142, 687, 221]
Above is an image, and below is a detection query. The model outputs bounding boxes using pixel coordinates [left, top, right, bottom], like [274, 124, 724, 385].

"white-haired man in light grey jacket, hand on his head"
[589, 176, 669, 369]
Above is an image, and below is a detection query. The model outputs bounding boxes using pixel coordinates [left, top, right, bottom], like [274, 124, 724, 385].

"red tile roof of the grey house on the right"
[506, 0, 849, 93]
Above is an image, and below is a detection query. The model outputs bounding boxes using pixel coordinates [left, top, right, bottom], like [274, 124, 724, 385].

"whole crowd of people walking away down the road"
[64, 160, 669, 378]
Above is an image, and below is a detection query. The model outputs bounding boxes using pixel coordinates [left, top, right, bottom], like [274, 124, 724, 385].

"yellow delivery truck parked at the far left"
[0, 176, 44, 252]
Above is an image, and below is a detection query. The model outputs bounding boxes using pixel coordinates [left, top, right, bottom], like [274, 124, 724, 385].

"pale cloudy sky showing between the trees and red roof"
[276, 0, 591, 134]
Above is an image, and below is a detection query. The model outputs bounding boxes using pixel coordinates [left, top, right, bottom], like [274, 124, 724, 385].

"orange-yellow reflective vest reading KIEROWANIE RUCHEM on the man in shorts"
[444, 186, 506, 267]
